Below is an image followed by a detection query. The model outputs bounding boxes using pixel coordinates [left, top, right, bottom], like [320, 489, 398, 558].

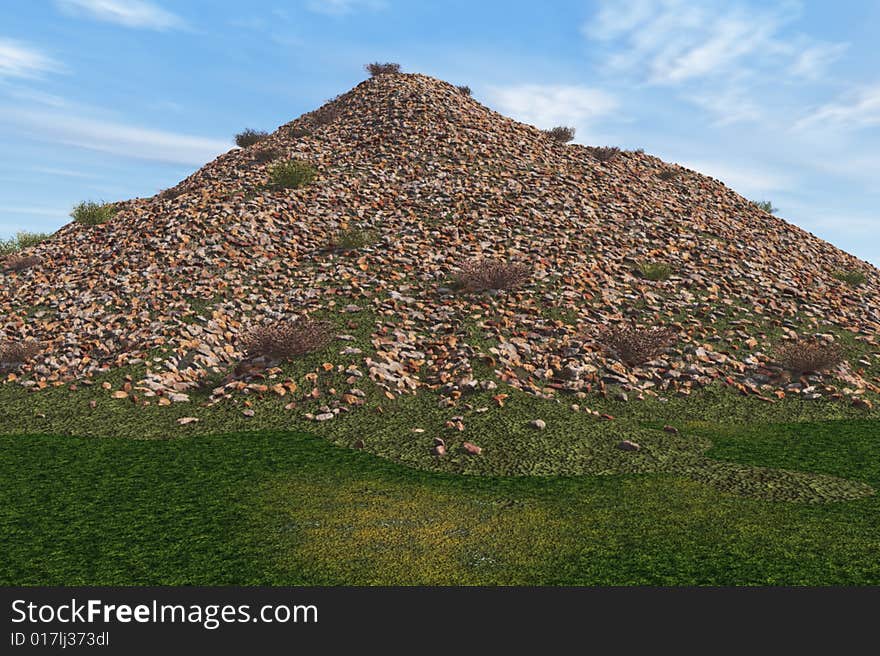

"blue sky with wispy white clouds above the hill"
[0, 0, 880, 264]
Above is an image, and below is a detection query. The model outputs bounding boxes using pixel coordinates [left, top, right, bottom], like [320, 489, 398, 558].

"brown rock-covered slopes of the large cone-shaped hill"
[0, 74, 880, 416]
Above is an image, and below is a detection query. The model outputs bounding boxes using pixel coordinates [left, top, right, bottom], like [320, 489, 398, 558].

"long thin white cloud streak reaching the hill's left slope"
[0, 106, 232, 166]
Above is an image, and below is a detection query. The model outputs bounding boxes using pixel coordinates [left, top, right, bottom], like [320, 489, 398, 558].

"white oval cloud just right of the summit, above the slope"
[488, 84, 617, 134]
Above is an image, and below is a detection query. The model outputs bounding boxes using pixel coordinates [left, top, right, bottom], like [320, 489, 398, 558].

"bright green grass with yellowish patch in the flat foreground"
[0, 419, 880, 585]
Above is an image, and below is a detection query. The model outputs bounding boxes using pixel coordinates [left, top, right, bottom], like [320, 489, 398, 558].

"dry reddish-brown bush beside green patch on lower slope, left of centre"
[242, 317, 333, 360]
